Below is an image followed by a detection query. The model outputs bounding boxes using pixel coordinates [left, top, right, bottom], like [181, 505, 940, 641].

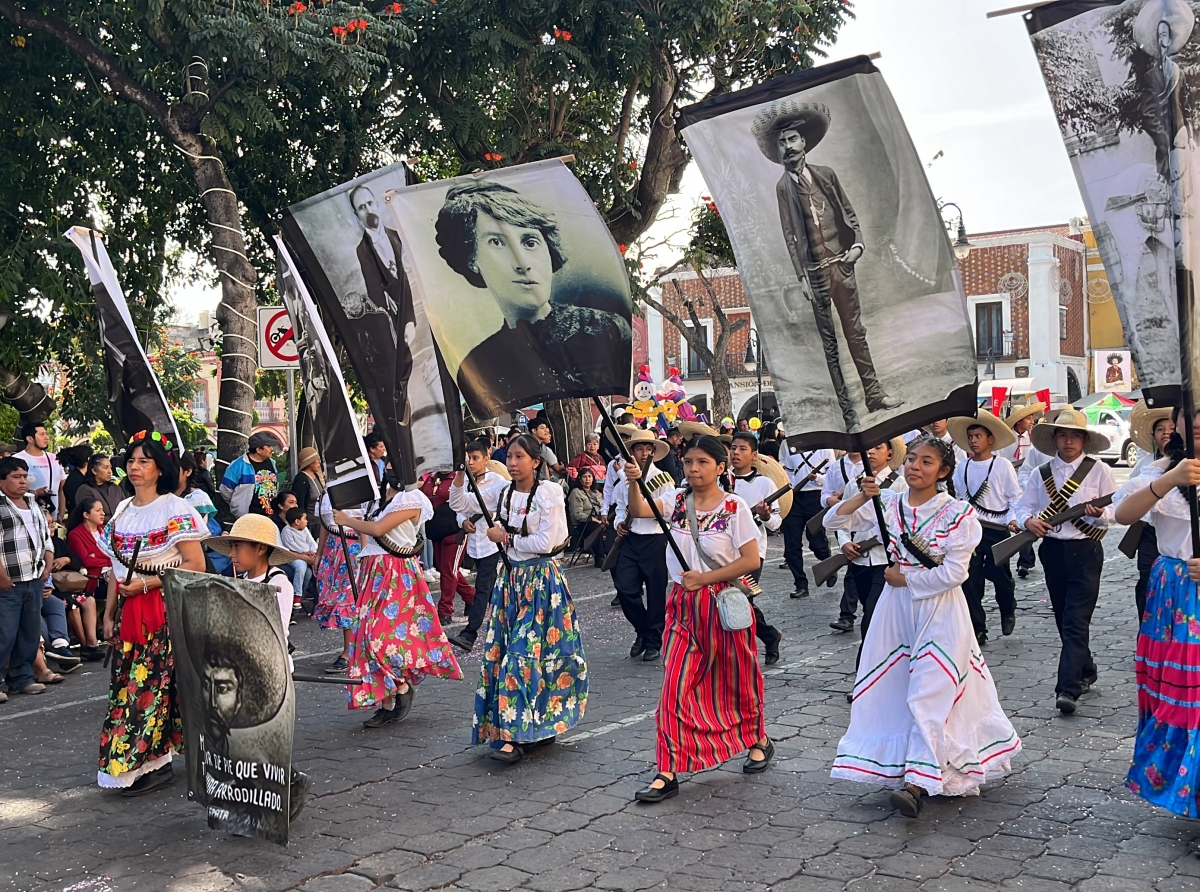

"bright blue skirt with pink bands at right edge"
[1126, 557, 1200, 818]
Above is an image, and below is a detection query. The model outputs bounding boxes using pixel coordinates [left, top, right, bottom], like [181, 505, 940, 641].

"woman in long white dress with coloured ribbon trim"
[832, 436, 1021, 818]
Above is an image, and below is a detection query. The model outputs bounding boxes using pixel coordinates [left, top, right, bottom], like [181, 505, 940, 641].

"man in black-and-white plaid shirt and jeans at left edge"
[0, 456, 54, 702]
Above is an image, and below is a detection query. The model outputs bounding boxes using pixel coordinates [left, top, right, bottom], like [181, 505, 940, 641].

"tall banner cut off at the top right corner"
[1026, 0, 1200, 406]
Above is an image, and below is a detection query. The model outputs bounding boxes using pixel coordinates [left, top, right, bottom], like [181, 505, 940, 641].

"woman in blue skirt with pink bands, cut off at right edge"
[1112, 405, 1200, 818]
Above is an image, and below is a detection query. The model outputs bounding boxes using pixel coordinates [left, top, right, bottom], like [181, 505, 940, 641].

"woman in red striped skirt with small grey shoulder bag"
[625, 436, 775, 802]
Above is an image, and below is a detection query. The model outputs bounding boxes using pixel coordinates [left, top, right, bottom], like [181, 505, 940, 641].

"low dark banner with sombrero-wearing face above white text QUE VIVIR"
[162, 570, 295, 845]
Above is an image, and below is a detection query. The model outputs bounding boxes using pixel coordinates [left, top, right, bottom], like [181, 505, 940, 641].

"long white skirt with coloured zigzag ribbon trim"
[832, 586, 1021, 796]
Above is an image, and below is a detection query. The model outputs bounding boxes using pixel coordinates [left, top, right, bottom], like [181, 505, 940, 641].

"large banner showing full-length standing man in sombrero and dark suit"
[678, 56, 977, 449]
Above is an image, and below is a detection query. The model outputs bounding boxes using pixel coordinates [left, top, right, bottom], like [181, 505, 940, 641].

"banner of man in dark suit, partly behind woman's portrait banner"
[282, 162, 463, 484]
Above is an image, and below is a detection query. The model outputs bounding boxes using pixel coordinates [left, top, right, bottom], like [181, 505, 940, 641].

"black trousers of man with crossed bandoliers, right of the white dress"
[1038, 537, 1104, 698]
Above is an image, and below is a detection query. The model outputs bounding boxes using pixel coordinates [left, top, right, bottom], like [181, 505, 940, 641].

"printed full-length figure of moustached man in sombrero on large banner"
[751, 100, 901, 426]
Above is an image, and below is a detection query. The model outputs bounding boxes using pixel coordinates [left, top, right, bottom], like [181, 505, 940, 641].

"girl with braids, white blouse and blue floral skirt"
[472, 435, 588, 765]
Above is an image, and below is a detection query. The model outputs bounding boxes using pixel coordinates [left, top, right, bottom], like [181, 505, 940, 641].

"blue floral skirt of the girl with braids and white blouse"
[472, 558, 588, 743]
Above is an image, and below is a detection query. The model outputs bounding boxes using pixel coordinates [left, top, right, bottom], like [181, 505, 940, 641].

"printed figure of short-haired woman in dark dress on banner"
[436, 182, 631, 418]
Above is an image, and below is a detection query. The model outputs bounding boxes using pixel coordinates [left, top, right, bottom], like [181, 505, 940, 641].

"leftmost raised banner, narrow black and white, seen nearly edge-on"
[65, 226, 184, 450]
